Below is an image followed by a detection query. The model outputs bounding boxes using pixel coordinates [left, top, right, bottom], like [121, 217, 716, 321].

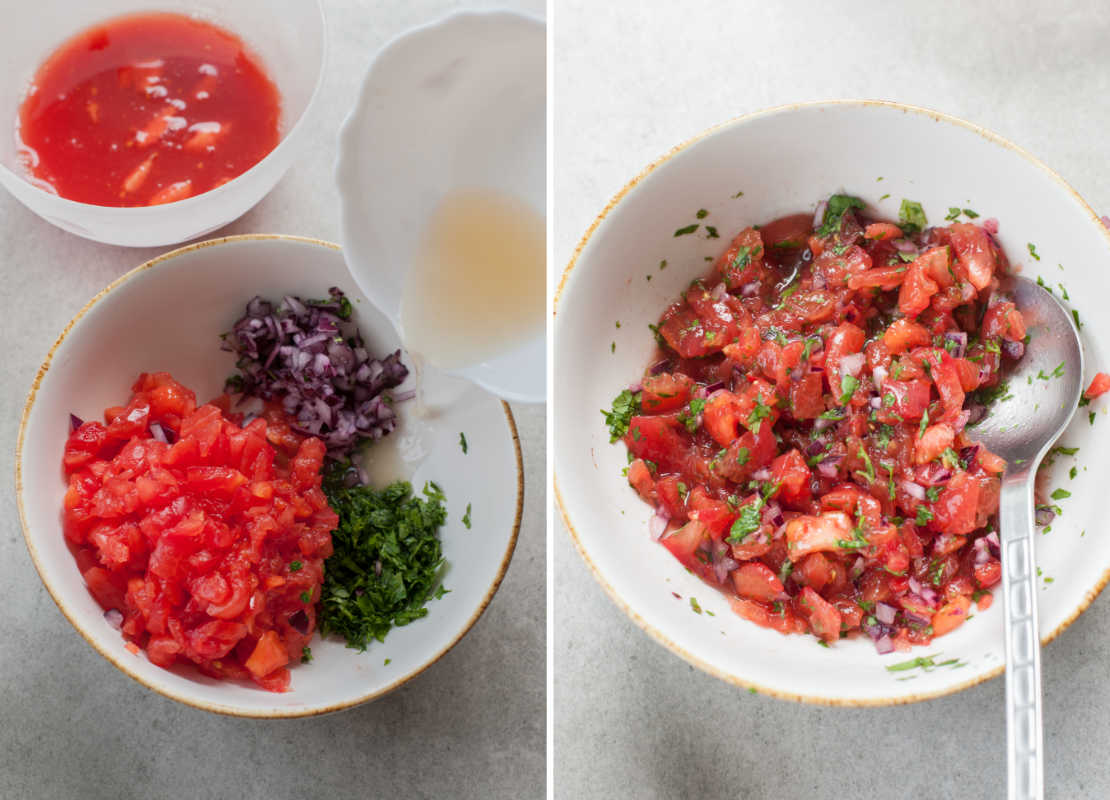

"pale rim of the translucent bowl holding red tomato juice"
[0, 0, 327, 215]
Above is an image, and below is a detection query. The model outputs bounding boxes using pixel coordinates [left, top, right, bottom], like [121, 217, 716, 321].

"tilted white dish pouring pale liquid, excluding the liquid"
[335, 11, 547, 403]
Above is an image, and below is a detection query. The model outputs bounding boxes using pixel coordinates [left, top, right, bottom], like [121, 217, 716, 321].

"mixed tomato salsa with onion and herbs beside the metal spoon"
[611, 195, 1021, 652]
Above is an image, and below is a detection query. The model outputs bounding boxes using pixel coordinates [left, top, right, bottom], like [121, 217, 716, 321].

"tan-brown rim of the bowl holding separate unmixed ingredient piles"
[14, 233, 524, 719]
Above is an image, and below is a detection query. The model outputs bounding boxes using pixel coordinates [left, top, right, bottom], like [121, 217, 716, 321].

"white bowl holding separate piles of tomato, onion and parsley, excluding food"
[16, 235, 523, 717]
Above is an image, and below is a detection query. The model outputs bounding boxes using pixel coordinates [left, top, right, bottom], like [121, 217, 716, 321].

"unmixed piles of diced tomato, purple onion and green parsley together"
[63, 288, 446, 691]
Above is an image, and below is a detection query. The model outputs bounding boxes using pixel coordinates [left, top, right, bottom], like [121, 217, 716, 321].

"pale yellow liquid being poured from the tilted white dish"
[401, 189, 547, 369]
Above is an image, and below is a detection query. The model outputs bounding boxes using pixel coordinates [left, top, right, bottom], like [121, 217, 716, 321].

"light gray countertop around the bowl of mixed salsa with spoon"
[553, 0, 1110, 800]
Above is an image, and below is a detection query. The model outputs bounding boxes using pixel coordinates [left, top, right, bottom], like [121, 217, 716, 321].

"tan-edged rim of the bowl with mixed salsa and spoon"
[552, 99, 1110, 708]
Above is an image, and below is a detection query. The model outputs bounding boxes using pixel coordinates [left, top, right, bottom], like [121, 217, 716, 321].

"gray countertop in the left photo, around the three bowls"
[0, 0, 547, 800]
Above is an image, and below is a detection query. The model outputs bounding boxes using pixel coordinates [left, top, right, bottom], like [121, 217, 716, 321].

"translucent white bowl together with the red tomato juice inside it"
[0, 0, 325, 246]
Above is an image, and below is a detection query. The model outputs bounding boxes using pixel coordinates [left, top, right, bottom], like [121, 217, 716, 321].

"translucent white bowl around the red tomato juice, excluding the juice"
[0, 0, 326, 247]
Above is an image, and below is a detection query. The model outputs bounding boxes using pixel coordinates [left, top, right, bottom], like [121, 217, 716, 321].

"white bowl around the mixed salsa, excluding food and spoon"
[552, 101, 1110, 706]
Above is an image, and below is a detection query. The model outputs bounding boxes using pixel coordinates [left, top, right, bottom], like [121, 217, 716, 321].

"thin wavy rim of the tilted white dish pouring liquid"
[332, 8, 551, 405]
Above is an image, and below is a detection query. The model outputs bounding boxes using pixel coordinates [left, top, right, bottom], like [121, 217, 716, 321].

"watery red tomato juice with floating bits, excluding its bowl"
[19, 13, 281, 206]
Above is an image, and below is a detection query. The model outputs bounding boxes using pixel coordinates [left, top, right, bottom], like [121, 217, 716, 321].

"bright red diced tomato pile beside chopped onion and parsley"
[63, 373, 337, 691]
